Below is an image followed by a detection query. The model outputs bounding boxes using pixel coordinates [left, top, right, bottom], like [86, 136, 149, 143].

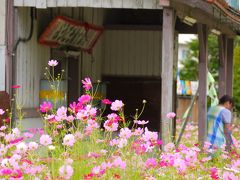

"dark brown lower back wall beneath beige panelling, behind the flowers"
[103, 76, 161, 132]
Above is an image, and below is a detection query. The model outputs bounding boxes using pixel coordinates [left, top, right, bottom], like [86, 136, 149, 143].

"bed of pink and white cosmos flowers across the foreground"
[0, 61, 240, 180]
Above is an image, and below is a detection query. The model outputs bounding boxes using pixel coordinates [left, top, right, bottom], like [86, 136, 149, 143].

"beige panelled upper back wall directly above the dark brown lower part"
[102, 30, 161, 77]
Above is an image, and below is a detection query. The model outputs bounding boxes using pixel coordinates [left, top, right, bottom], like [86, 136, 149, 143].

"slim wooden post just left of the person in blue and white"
[198, 24, 208, 145]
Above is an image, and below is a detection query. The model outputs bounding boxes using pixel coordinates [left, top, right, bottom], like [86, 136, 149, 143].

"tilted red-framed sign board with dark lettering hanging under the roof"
[39, 16, 103, 53]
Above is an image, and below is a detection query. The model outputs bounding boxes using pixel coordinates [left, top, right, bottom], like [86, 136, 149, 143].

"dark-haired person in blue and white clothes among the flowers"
[206, 95, 234, 151]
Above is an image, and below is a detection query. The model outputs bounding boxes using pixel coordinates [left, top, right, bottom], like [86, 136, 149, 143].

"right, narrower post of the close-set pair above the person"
[226, 38, 234, 96]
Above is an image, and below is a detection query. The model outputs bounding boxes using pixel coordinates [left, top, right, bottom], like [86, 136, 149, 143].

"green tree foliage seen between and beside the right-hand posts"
[180, 35, 240, 114]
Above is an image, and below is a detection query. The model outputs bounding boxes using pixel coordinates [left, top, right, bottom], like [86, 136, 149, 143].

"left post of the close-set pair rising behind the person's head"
[218, 34, 227, 98]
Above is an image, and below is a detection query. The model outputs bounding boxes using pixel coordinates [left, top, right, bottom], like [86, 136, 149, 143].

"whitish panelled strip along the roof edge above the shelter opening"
[14, 0, 162, 9]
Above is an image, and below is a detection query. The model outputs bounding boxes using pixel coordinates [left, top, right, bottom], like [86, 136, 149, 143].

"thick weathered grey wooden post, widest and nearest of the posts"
[160, 8, 175, 145]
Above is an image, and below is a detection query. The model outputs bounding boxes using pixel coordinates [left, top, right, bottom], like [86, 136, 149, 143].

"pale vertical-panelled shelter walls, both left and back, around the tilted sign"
[17, 8, 161, 108]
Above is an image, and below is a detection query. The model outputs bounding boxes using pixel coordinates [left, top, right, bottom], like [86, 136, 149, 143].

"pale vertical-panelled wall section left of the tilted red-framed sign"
[16, 8, 50, 108]
